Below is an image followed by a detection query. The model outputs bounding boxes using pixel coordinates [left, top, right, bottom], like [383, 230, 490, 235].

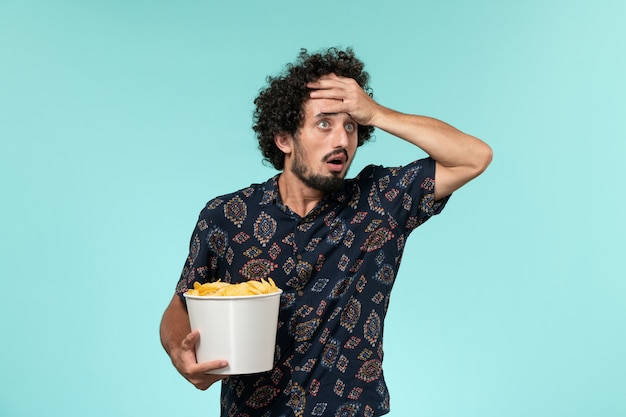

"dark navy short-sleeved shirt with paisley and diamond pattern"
[177, 158, 447, 417]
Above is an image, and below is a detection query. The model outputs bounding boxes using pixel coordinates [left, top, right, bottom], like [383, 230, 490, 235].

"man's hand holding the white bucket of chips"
[171, 330, 228, 391]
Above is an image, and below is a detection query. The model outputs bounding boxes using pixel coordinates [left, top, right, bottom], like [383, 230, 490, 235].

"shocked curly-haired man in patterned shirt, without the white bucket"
[161, 48, 492, 417]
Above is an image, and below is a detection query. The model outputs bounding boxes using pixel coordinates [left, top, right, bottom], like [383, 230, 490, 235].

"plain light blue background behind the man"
[0, 0, 626, 417]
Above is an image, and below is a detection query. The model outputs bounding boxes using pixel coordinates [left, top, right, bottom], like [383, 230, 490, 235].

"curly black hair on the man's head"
[252, 48, 374, 170]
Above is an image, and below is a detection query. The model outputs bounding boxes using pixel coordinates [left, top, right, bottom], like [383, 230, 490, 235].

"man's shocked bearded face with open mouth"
[290, 99, 358, 193]
